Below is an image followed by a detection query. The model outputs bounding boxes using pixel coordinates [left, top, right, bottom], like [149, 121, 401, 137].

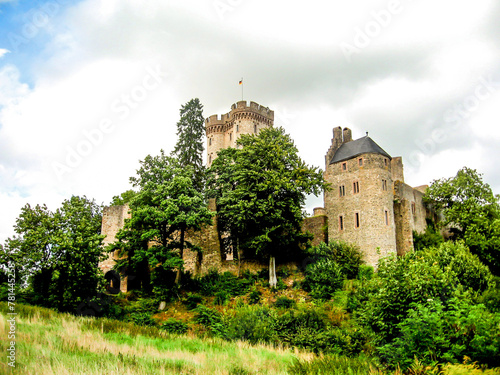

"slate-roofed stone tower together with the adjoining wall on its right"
[324, 127, 427, 267]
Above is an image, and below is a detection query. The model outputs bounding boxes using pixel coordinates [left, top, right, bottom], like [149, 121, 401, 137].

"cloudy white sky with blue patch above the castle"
[0, 0, 500, 243]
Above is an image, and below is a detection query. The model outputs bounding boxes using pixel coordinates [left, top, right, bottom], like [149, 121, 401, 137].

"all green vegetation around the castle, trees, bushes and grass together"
[0, 106, 500, 375]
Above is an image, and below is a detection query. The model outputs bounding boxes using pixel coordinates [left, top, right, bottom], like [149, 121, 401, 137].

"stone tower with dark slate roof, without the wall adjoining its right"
[324, 129, 396, 267]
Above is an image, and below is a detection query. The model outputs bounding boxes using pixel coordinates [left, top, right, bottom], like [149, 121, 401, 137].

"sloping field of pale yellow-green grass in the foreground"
[0, 303, 312, 375]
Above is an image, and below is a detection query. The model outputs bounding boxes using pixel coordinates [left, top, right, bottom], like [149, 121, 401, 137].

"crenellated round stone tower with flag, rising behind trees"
[205, 101, 274, 166]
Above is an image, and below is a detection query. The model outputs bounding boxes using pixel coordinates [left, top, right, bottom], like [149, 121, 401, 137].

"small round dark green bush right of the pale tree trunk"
[302, 259, 344, 300]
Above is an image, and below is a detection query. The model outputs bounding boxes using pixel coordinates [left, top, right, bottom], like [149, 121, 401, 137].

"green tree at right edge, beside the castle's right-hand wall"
[424, 167, 500, 274]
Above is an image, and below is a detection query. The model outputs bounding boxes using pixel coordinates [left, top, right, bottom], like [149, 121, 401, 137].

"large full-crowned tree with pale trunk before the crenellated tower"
[208, 128, 326, 287]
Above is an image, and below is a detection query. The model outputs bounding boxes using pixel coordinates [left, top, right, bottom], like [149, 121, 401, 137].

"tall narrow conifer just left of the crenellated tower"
[172, 98, 205, 191]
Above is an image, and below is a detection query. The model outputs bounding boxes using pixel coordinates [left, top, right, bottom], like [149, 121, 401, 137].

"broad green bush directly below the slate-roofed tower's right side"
[358, 242, 491, 343]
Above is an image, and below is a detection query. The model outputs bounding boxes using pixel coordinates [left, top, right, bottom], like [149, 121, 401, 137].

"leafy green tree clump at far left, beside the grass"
[2, 196, 104, 311]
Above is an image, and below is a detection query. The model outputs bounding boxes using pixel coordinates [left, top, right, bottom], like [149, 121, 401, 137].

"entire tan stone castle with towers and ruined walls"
[100, 101, 431, 291]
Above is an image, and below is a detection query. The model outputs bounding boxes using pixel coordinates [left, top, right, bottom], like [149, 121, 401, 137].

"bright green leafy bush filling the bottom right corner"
[380, 297, 500, 369]
